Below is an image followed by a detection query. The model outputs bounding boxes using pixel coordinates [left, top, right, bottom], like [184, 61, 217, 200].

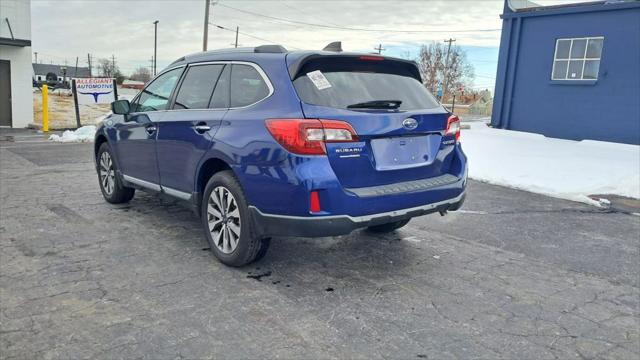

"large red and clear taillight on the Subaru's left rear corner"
[266, 119, 358, 155]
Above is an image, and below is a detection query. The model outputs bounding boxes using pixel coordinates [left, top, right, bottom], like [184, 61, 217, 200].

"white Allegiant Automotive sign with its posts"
[71, 78, 118, 127]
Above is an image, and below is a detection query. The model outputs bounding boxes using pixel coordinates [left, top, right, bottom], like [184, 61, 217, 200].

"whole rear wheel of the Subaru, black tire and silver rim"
[201, 170, 270, 267]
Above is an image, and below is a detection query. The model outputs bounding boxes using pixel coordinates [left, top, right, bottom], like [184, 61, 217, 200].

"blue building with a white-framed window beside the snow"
[491, 0, 640, 144]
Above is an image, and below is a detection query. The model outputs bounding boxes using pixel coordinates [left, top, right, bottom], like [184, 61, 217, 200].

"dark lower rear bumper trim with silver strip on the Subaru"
[249, 191, 466, 237]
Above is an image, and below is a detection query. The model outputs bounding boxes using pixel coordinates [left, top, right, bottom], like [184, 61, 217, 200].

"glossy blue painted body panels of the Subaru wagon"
[96, 49, 466, 226]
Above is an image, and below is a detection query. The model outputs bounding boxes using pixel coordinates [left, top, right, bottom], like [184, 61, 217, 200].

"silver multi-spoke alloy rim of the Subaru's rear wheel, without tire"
[207, 186, 240, 254]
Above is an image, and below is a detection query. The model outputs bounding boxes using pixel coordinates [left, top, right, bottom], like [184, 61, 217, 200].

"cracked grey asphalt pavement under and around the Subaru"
[0, 137, 640, 359]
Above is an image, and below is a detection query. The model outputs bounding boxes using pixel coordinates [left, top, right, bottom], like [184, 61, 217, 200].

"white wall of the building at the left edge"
[0, 0, 33, 127]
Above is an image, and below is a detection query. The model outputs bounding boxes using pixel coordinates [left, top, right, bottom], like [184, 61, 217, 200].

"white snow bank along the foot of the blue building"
[461, 122, 640, 205]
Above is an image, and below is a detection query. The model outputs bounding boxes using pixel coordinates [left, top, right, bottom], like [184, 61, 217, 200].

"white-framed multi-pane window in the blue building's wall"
[551, 36, 604, 80]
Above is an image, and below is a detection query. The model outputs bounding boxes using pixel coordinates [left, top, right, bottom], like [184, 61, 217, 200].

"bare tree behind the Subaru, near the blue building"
[416, 42, 474, 101]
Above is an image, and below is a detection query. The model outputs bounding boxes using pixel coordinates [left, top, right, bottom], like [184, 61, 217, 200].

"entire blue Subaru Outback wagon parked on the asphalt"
[95, 44, 467, 266]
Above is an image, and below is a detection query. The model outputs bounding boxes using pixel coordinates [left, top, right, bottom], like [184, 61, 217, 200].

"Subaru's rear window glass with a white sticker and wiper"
[293, 57, 440, 110]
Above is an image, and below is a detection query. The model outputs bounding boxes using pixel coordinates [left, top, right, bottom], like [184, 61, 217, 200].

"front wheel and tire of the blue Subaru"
[96, 142, 136, 204]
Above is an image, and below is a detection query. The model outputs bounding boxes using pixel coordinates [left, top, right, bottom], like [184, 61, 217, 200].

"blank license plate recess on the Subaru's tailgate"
[371, 135, 433, 171]
